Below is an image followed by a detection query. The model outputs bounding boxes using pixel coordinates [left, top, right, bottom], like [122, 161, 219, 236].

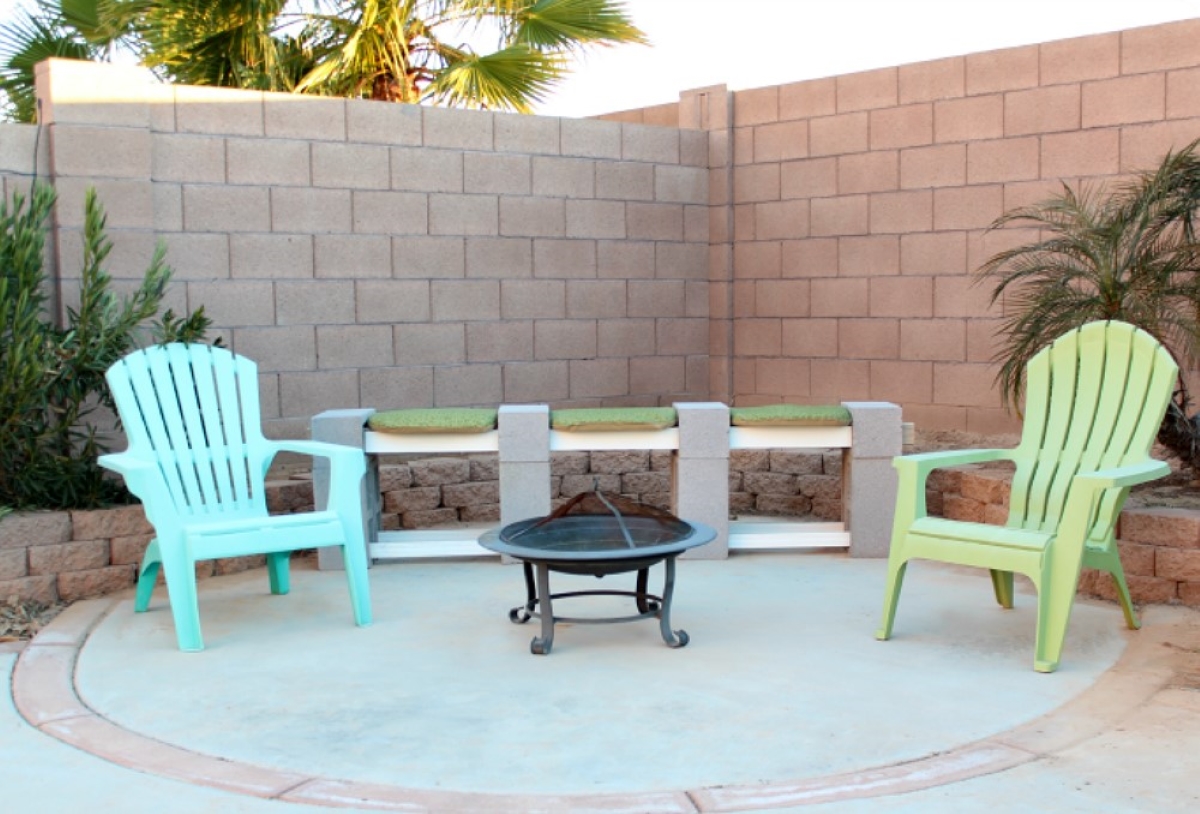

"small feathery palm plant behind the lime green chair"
[977, 140, 1200, 471]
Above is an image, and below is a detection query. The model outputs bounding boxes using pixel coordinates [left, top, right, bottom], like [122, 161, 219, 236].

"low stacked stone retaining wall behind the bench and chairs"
[0, 450, 1200, 606]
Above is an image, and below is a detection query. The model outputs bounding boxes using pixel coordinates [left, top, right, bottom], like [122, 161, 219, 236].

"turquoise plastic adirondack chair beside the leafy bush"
[100, 343, 371, 651]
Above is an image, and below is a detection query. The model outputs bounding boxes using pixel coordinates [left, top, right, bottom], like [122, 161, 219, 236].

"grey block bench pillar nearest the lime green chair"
[841, 401, 904, 557]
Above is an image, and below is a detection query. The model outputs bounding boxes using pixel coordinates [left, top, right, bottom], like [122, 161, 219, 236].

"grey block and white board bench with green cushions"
[312, 402, 901, 568]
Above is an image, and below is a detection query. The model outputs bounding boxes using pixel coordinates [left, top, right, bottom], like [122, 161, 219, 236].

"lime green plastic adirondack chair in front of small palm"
[875, 322, 1178, 672]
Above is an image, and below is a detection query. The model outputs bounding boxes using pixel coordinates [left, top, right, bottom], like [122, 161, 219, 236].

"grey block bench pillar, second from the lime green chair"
[671, 401, 730, 559]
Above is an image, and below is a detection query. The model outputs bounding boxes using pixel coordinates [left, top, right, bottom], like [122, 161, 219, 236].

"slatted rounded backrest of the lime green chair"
[1009, 322, 1177, 544]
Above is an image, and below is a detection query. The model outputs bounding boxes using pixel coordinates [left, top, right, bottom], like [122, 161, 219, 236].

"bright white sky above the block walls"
[535, 0, 1200, 116]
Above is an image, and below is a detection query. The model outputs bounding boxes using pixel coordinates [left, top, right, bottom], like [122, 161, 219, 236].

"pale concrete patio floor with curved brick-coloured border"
[0, 552, 1200, 814]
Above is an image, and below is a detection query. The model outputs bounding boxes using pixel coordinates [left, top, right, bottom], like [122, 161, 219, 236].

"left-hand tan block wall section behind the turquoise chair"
[30, 60, 708, 436]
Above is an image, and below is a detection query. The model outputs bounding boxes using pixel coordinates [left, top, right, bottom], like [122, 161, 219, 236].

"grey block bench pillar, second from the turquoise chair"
[498, 405, 550, 526]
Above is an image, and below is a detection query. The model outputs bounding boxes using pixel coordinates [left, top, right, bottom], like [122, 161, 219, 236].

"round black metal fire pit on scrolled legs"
[479, 491, 716, 656]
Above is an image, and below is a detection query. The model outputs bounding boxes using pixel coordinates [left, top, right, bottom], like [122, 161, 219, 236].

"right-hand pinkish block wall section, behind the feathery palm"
[610, 20, 1200, 432]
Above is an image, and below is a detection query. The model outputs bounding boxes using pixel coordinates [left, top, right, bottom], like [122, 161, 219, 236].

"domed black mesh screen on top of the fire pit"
[500, 490, 692, 549]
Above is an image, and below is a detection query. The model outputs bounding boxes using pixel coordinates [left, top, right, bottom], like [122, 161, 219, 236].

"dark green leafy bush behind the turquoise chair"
[0, 184, 210, 509]
